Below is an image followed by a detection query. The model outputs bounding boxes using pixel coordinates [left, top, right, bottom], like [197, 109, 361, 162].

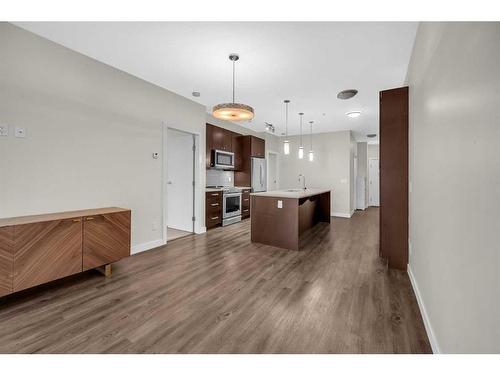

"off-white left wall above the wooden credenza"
[0, 23, 206, 253]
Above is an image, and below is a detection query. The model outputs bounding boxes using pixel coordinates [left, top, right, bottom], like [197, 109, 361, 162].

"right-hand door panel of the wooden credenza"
[83, 211, 130, 271]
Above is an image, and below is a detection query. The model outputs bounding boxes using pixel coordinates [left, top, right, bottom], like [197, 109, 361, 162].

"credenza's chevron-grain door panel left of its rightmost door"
[13, 218, 82, 292]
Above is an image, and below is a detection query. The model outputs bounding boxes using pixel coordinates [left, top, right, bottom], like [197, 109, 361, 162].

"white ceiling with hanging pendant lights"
[17, 22, 418, 140]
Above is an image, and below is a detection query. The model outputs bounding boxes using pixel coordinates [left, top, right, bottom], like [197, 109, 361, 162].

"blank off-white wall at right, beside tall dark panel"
[407, 22, 500, 353]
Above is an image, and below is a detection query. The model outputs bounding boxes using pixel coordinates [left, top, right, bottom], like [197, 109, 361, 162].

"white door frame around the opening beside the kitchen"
[161, 122, 205, 245]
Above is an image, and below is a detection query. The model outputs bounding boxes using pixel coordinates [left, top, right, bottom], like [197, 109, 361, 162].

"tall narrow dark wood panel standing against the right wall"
[379, 87, 408, 270]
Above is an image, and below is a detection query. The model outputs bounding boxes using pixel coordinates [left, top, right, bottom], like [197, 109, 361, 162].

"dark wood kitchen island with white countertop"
[250, 189, 330, 250]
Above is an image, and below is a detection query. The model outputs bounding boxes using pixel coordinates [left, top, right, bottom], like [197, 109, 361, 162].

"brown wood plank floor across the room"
[0, 208, 431, 353]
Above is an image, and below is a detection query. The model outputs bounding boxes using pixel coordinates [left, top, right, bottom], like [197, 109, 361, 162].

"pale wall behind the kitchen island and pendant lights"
[279, 130, 351, 217]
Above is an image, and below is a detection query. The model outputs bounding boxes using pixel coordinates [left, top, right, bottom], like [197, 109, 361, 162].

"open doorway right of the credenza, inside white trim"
[165, 128, 196, 242]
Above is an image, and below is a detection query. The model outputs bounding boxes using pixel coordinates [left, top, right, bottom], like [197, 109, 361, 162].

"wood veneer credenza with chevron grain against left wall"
[0, 207, 130, 296]
